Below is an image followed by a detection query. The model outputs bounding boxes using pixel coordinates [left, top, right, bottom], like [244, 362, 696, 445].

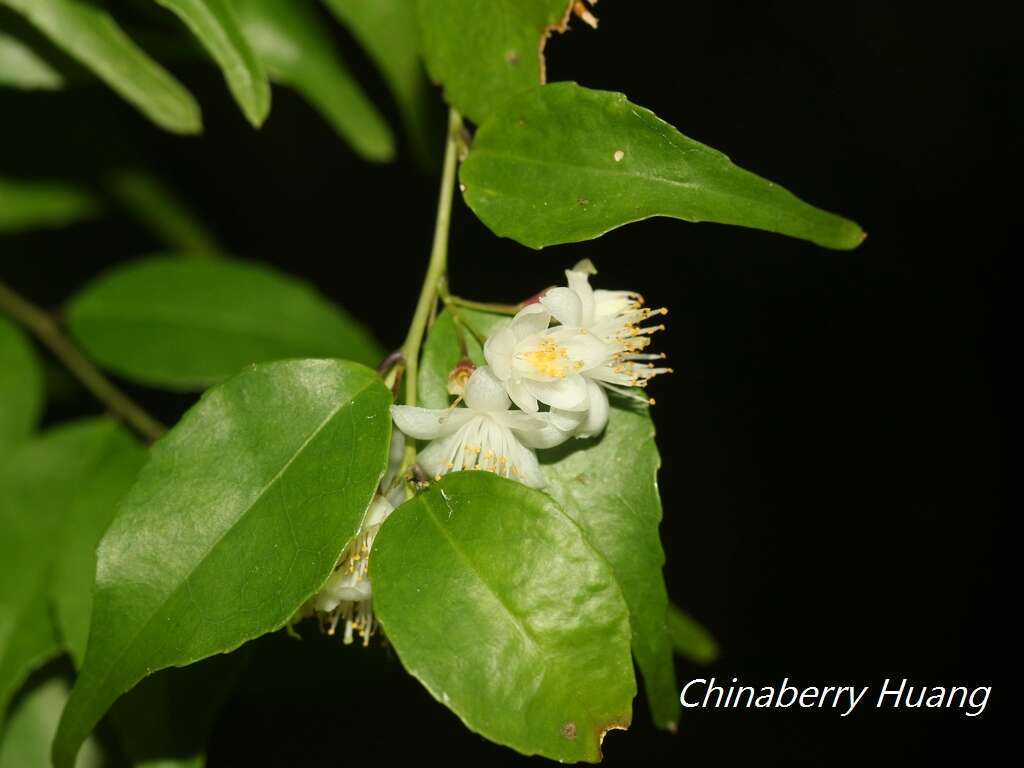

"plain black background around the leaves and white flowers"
[0, 0, 1007, 768]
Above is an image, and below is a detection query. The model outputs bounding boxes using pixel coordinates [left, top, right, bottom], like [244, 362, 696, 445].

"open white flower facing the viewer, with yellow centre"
[483, 304, 608, 421]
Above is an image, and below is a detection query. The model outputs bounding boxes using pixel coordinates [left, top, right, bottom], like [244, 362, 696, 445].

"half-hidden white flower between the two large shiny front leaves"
[300, 432, 406, 645]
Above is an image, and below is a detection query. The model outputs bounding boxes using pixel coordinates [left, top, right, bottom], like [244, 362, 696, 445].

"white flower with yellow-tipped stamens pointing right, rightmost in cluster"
[541, 259, 672, 437]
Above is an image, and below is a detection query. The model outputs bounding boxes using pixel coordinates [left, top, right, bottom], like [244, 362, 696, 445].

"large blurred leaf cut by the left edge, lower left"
[0, 419, 132, 721]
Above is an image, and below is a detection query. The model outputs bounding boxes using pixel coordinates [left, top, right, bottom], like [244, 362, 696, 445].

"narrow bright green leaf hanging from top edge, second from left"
[156, 0, 270, 128]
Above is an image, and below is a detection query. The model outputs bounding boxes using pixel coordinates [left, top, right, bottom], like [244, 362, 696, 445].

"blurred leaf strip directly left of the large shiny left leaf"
[50, 430, 145, 667]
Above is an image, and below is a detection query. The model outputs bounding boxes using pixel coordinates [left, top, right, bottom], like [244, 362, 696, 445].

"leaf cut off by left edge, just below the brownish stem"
[0, 316, 44, 459]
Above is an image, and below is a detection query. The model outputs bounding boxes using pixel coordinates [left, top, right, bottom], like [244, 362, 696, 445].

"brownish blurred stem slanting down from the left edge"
[0, 283, 167, 440]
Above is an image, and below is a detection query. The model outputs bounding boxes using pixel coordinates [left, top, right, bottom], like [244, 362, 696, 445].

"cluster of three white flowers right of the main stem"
[391, 260, 670, 487]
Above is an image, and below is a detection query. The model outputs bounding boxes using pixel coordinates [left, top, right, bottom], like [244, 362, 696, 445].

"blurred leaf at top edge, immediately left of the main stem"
[325, 0, 431, 158]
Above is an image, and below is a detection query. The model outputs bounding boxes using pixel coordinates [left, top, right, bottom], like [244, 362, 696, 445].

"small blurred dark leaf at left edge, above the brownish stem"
[0, 177, 99, 232]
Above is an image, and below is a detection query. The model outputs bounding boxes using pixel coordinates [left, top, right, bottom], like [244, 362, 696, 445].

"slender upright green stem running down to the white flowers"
[399, 110, 462, 475]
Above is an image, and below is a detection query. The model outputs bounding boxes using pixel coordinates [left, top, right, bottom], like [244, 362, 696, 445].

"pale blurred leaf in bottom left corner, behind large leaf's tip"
[0, 675, 105, 768]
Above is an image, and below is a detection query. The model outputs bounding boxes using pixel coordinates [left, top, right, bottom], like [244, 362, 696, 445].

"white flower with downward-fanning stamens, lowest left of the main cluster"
[391, 366, 568, 488]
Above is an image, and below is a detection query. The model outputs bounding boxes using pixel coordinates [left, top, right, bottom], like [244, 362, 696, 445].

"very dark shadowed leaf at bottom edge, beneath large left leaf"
[109, 648, 249, 768]
